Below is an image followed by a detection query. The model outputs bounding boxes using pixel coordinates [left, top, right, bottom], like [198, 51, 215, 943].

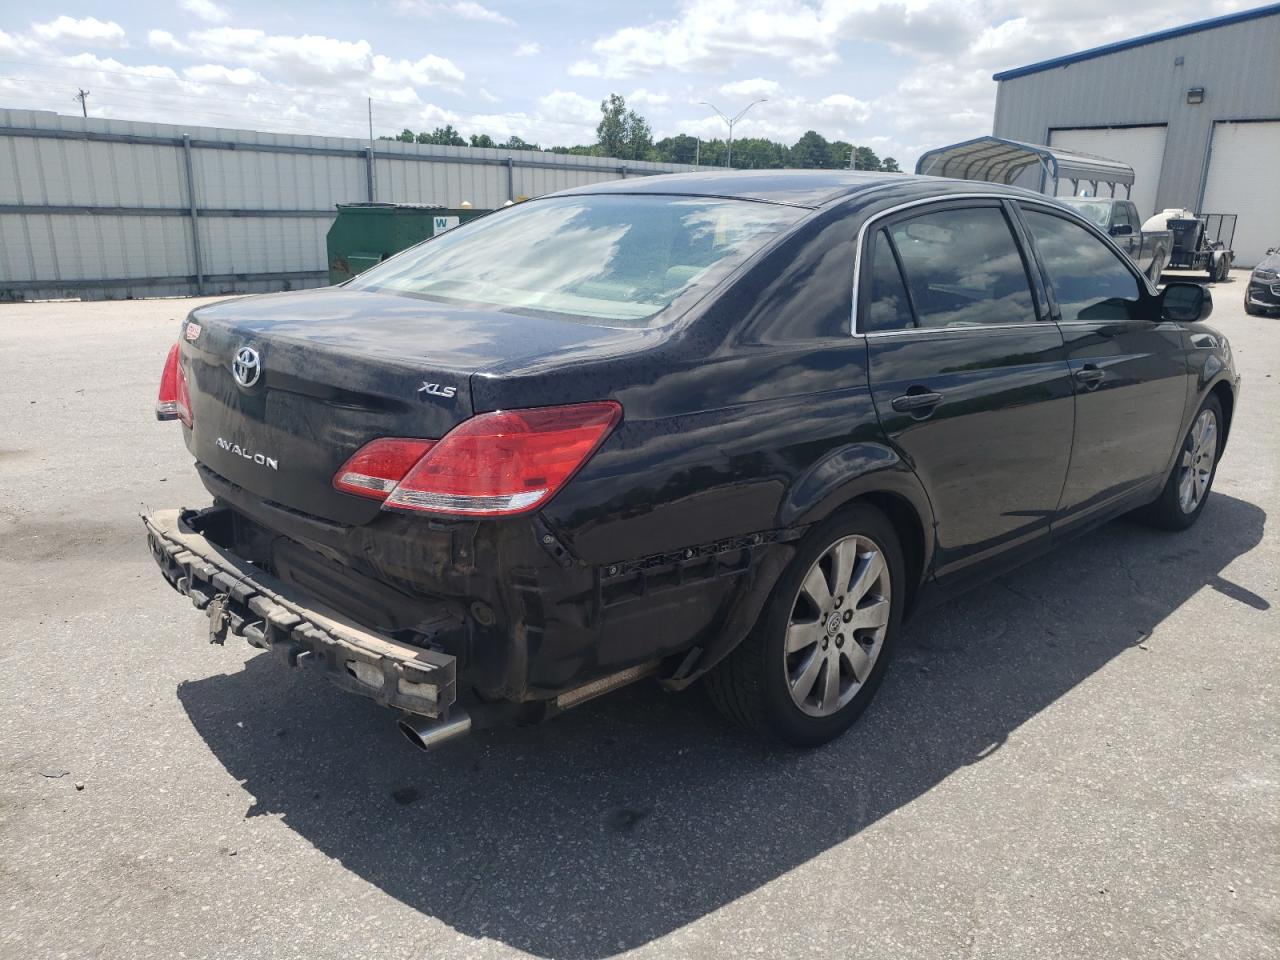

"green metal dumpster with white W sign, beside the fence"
[325, 202, 488, 283]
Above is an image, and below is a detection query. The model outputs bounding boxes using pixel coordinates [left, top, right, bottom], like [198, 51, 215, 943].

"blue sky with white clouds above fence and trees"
[0, 0, 1251, 166]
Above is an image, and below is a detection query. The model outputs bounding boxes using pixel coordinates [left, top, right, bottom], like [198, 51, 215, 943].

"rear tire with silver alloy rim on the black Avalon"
[704, 504, 906, 746]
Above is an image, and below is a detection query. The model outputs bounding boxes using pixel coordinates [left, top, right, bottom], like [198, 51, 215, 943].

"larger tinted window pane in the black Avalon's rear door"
[888, 207, 1037, 328]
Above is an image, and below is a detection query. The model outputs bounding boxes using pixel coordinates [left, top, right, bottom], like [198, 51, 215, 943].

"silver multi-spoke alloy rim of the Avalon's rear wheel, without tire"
[783, 535, 892, 717]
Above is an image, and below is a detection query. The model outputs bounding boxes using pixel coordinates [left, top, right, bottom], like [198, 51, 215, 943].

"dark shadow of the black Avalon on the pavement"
[178, 494, 1267, 960]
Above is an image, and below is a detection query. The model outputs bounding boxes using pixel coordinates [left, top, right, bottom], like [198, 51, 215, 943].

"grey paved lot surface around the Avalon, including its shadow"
[0, 273, 1280, 960]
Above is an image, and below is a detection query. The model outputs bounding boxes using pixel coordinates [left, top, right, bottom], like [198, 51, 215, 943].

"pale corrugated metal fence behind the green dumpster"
[0, 110, 695, 300]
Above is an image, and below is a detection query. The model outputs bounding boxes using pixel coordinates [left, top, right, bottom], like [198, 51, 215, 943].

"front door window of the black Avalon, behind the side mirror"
[1024, 210, 1140, 324]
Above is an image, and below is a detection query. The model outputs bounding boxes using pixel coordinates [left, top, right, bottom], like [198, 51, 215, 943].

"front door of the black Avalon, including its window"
[1020, 202, 1188, 535]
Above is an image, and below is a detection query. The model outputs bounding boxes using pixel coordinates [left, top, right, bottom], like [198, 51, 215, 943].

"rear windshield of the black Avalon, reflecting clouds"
[348, 195, 808, 326]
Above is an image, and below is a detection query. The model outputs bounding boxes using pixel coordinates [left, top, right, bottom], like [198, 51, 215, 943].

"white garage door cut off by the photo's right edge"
[1199, 120, 1280, 266]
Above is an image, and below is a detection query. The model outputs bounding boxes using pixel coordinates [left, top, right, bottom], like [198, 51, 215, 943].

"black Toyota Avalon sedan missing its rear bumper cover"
[146, 172, 1239, 746]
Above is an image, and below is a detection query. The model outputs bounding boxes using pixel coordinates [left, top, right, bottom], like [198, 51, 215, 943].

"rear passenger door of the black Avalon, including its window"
[855, 200, 1073, 580]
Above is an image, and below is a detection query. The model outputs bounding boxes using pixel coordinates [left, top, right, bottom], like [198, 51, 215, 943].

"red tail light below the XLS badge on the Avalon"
[334, 401, 622, 517]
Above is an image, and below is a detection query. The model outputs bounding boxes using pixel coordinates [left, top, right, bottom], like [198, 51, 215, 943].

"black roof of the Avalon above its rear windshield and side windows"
[556, 170, 1044, 207]
